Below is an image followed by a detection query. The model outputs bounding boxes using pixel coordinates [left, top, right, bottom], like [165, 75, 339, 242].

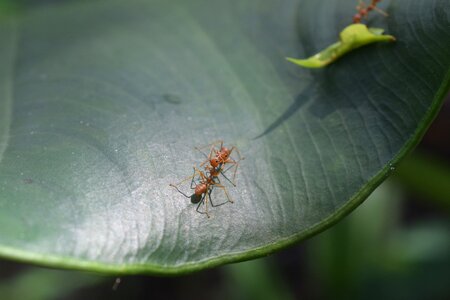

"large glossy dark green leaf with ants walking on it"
[0, 0, 450, 274]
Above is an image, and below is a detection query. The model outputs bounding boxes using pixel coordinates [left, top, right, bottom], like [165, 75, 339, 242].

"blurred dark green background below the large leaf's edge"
[0, 98, 450, 300]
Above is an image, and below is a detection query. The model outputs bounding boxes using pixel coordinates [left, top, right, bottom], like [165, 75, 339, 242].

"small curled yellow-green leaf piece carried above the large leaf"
[286, 24, 395, 68]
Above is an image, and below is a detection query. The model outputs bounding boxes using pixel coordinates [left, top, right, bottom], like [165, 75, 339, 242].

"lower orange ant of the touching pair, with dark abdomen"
[170, 167, 233, 218]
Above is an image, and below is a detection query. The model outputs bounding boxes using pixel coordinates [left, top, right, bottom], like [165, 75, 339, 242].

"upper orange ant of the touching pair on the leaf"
[195, 140, 244, 186]
